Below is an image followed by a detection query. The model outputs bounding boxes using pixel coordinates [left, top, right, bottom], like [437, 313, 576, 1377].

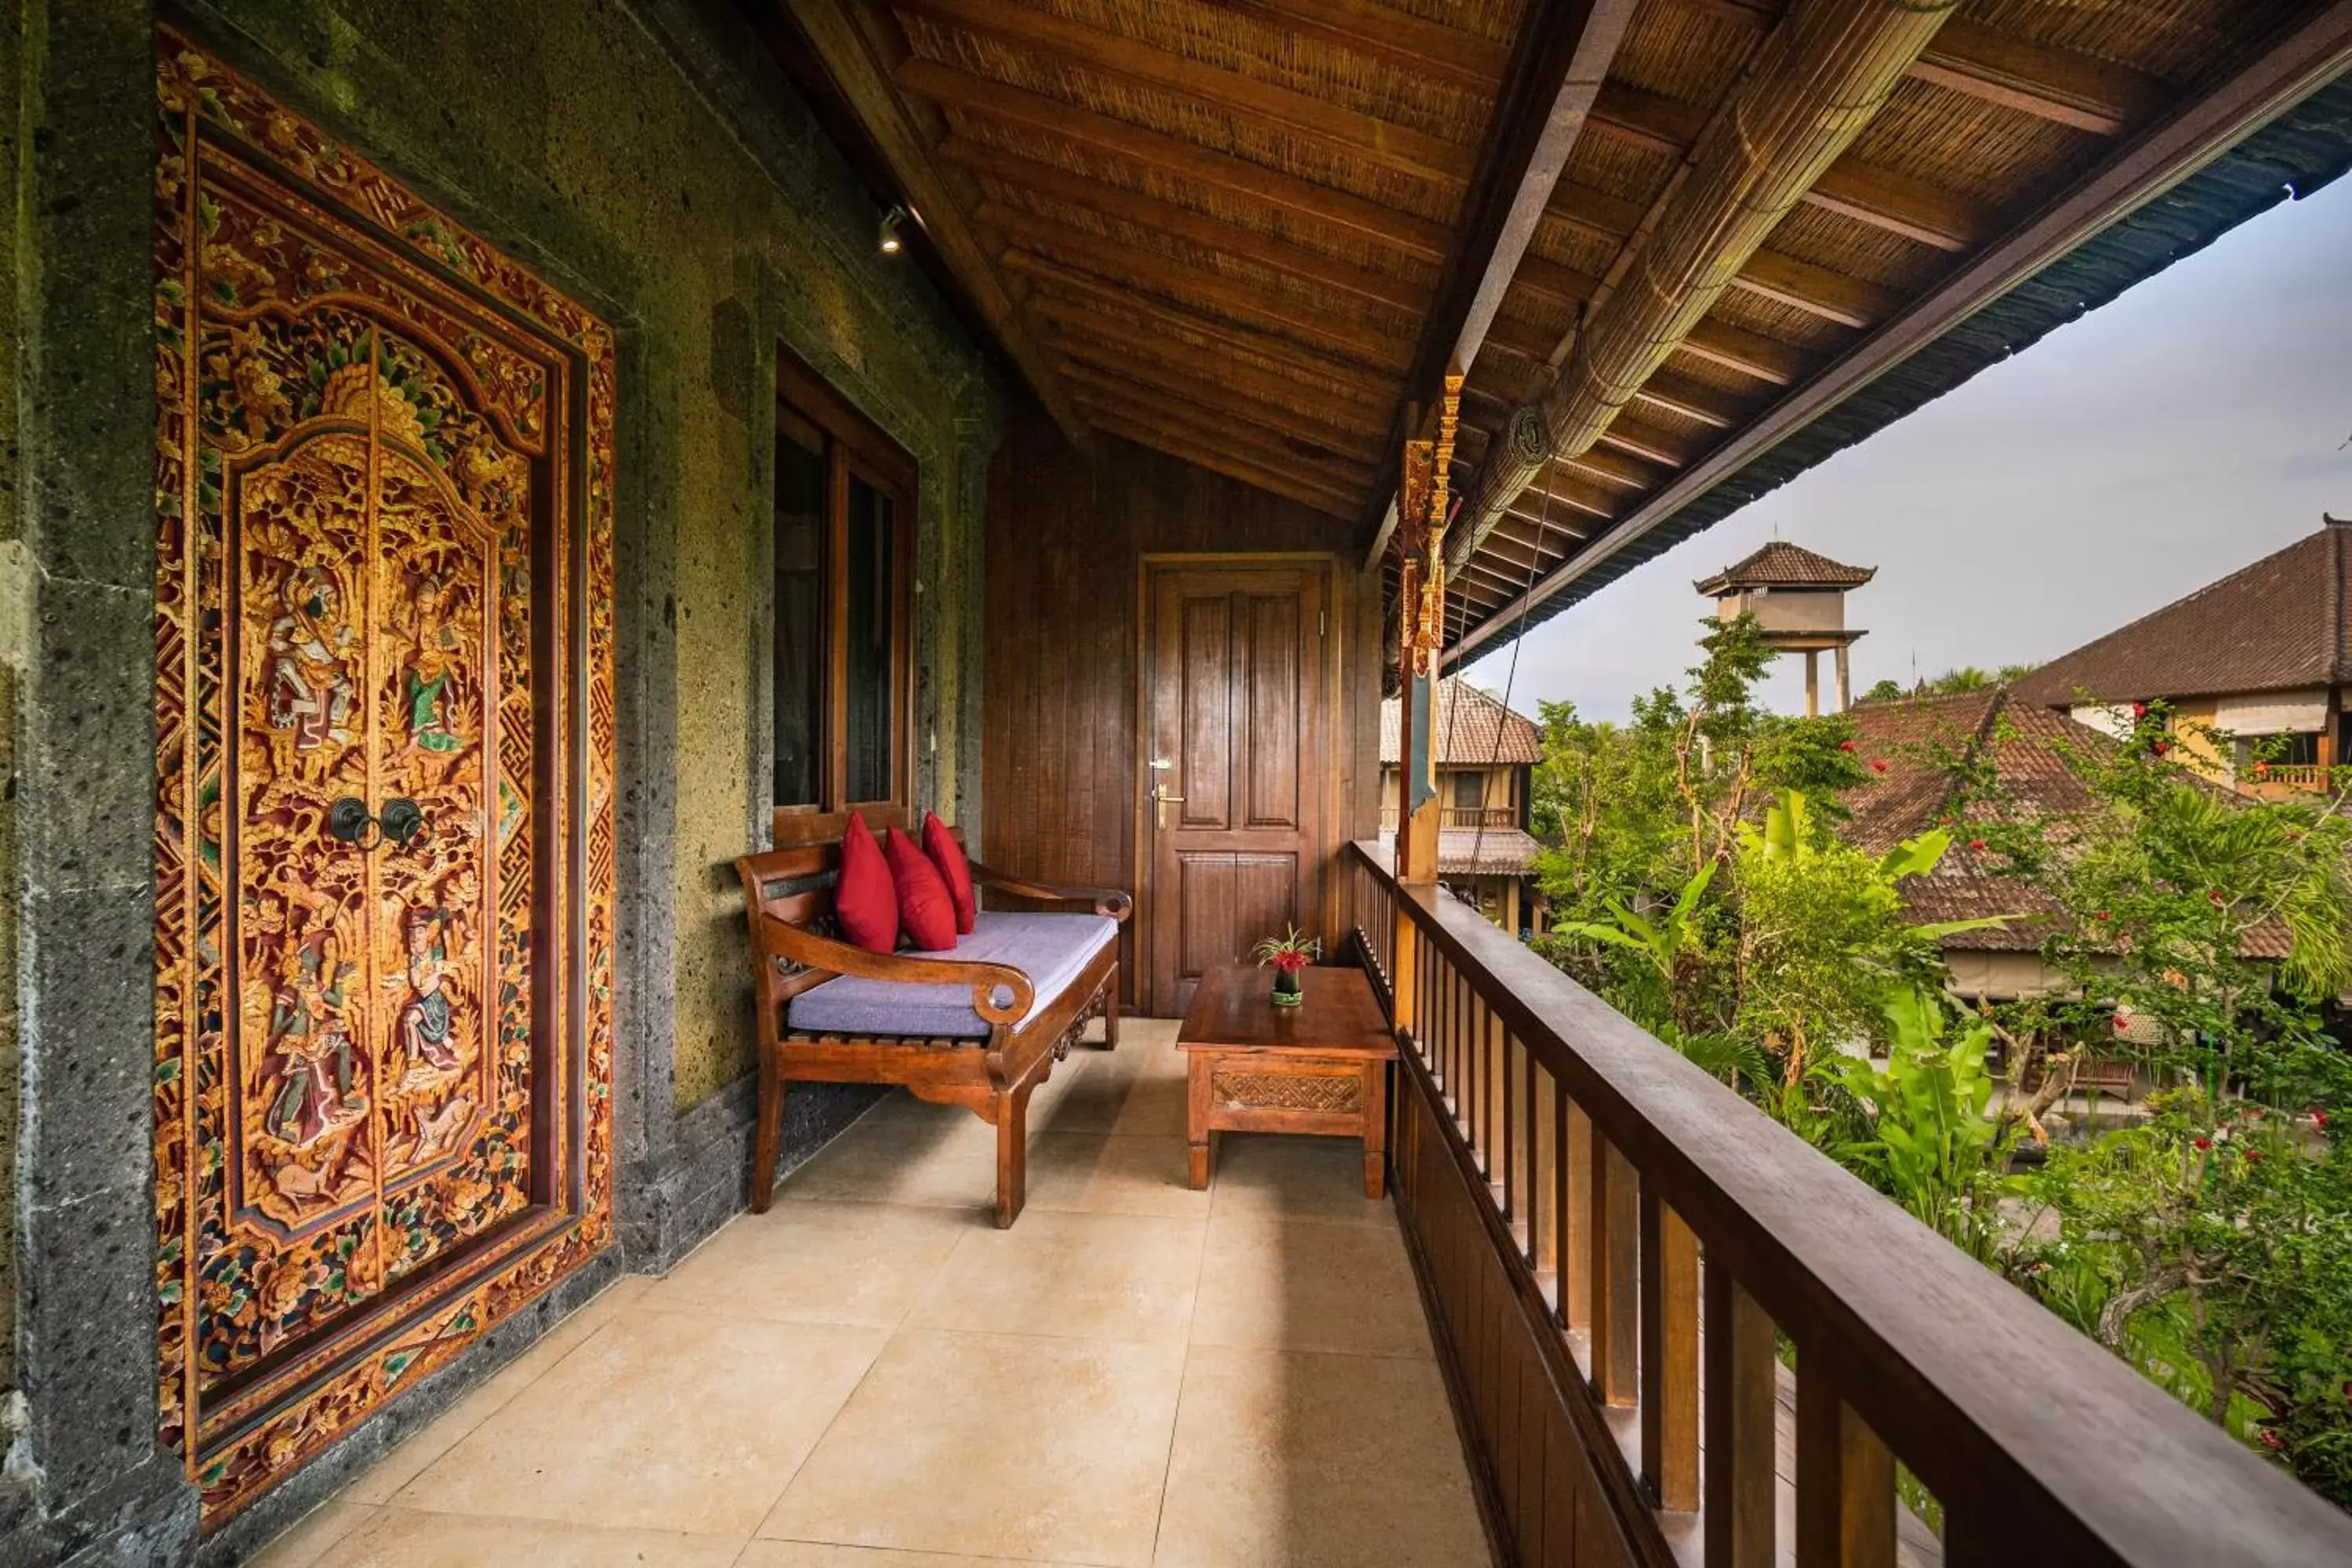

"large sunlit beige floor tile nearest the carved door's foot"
[397, 1309, 887, 1537]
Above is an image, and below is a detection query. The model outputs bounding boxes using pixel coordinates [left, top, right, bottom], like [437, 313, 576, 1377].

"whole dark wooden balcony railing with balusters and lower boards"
[1345, 844, 2352, 1568]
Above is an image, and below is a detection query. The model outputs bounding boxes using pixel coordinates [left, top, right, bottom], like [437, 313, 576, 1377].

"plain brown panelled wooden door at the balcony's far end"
[1141, 562, 1336, 1018]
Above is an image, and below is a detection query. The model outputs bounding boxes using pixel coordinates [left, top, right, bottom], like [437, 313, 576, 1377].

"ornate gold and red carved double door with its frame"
[155, 35, 614, 1523]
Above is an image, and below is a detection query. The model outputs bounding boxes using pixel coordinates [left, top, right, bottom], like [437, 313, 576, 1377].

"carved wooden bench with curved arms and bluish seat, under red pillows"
[736, 815, 1134, 1227]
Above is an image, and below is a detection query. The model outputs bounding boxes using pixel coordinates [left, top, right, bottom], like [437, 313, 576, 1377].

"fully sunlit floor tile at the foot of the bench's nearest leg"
[908, 1208, 1207, 1345]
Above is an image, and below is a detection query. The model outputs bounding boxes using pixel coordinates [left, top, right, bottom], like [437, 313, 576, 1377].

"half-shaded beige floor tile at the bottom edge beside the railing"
[1152, 1354, 1486, 1568]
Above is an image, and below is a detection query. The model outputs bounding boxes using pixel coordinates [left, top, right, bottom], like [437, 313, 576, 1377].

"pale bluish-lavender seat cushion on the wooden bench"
[783, 909, 1120, 1039]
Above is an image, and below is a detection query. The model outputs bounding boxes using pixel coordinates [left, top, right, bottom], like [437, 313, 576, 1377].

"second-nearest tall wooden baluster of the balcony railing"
[1703, 1250, 1780, 1568]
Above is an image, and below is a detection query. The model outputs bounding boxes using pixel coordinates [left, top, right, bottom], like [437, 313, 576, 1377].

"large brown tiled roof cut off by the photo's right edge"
[2018, 520, 2352, 708]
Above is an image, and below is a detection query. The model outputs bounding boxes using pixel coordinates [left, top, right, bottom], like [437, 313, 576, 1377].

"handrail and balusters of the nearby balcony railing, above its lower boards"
[1345, 841, 2352, 1568]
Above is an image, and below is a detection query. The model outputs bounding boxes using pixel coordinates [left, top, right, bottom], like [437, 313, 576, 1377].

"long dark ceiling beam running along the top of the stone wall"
[786, 0, 1087, 447]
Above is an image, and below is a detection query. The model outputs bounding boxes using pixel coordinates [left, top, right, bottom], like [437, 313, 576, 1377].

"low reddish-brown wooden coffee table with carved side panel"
[1176, 964, 1397, 1199]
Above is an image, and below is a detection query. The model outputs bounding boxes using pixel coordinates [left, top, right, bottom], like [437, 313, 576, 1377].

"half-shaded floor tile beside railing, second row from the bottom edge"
[1192, 1215, 1432, 1356]
